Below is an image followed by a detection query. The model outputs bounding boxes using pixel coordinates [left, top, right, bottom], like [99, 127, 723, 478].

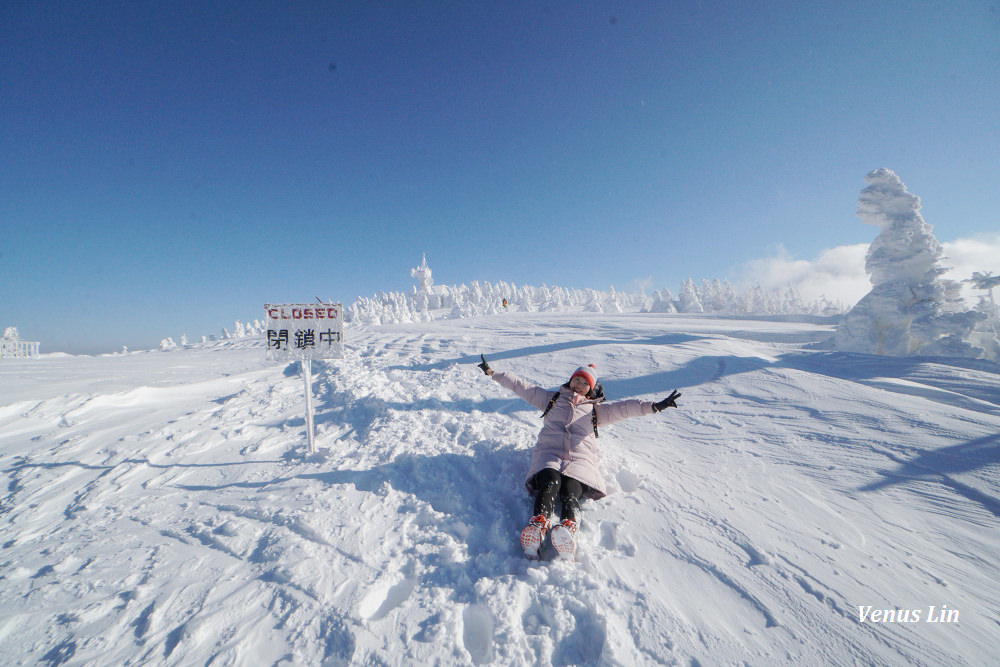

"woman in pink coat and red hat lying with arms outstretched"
[479, 355, 680, 560]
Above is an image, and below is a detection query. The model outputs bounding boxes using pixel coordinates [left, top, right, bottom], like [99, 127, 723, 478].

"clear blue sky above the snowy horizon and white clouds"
[0, 0, 1000, 353]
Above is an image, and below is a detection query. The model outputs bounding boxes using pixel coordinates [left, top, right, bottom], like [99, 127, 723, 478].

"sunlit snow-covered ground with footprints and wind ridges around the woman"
[0, 313, 1000, 665]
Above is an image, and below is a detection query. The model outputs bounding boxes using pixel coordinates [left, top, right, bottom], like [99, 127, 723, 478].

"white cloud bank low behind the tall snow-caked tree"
[740, 234, 1000, 306]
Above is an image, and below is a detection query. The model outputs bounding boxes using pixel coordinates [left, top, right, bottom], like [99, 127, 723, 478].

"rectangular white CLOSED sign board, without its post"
[264, 303, 344, 361]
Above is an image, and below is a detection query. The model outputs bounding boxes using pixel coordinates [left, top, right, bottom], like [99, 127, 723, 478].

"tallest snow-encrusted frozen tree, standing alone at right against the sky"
[835, 169, 986, 357]
